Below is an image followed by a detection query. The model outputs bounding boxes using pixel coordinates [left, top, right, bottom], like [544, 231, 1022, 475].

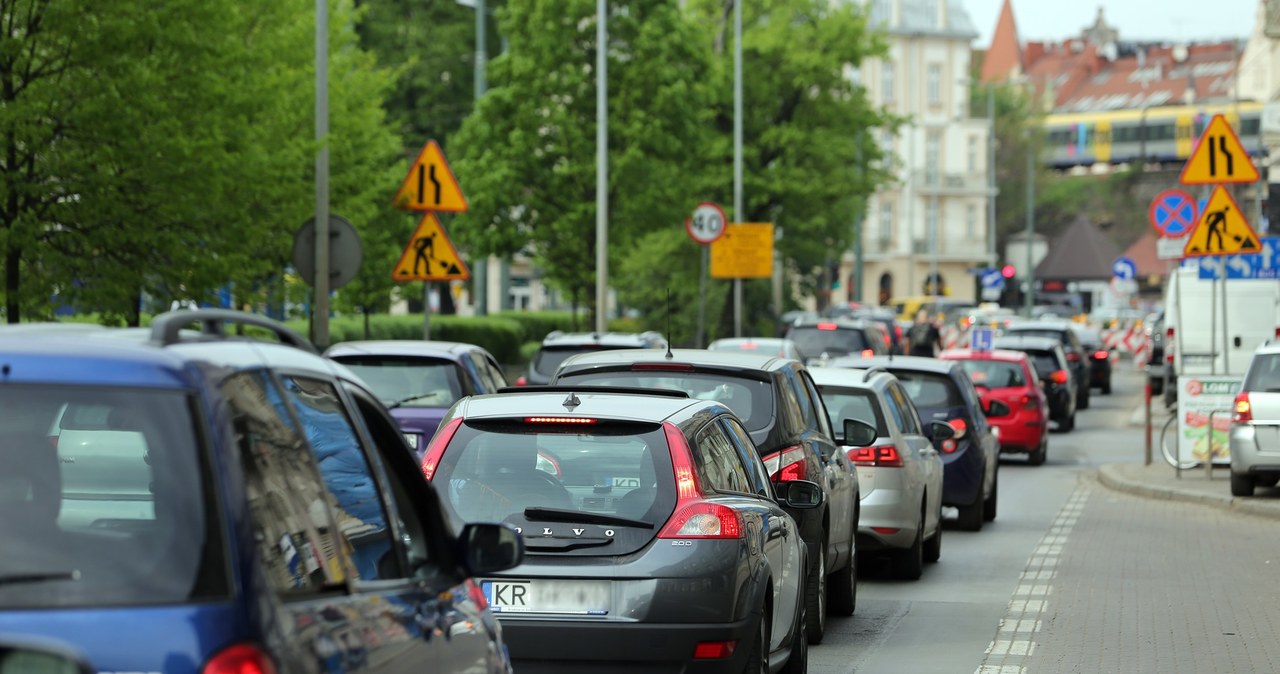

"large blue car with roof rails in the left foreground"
[0, 310, 524, 674]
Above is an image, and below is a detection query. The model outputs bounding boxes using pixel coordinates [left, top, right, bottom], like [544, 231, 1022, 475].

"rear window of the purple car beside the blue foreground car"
[334, 356, 462, 407]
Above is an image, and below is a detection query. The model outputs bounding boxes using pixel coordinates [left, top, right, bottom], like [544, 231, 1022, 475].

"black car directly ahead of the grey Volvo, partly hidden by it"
[554, 349, 859, 643]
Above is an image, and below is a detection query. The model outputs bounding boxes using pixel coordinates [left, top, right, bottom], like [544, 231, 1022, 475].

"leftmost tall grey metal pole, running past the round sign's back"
[311, 0, 329, 348]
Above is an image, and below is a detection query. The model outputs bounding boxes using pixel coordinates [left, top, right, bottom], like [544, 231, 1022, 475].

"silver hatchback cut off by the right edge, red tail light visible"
[1231, 340, 1280, 496]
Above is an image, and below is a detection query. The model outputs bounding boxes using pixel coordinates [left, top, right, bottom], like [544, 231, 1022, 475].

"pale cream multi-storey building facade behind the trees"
[833, 0, 992, 304]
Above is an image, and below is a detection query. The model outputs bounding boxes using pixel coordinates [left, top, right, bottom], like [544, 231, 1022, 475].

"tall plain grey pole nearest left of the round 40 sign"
[595, 0, 609, 333]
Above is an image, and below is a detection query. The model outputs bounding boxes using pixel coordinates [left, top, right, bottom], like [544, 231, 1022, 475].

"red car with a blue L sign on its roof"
[938, 349, 1048, 466]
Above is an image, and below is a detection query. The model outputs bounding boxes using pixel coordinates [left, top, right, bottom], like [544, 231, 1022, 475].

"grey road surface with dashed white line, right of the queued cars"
[809, 362, 1280, 674]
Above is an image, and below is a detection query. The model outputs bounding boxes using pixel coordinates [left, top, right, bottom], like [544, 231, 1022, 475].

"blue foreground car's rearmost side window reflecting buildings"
[221, 372, 347, 592]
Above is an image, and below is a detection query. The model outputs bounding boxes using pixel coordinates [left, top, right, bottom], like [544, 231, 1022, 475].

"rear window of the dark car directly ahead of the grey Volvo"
[556, 370, 773, 431]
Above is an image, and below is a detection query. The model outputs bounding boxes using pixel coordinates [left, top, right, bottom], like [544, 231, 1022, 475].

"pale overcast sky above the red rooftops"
[960, 0, 1261, 49]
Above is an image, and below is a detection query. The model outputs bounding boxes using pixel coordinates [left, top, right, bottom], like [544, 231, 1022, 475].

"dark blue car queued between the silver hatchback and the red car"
[831, 356, 1009, 531]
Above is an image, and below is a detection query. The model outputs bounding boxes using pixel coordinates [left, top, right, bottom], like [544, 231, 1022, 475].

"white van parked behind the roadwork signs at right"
[1165, 262, 1280, 404]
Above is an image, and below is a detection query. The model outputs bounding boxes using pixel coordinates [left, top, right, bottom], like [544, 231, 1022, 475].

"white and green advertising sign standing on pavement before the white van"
[1178, 375, 1243, 466]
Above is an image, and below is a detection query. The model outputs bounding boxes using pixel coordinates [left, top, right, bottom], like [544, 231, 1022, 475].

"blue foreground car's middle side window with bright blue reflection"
[280, 376, 401, 581]
